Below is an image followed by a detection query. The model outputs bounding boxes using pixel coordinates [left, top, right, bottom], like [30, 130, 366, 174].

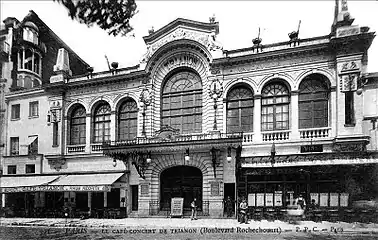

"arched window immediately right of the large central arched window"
[227, 86, 253, 132]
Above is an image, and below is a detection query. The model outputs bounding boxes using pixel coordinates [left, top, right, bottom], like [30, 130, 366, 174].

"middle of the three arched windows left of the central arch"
[93, 103, 110, 143]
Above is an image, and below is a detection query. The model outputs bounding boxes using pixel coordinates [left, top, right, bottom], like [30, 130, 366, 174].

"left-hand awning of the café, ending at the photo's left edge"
[0, 176, 59, 193]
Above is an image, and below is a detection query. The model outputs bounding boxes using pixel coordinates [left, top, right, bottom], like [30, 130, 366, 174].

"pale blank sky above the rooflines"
[0, 0, 378, 72]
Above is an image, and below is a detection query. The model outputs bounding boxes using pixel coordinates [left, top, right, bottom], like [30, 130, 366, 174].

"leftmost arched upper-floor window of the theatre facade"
[70, 106, 86, 145]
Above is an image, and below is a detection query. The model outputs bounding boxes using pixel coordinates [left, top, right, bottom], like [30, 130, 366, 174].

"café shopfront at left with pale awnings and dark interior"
[1, 173, 127, 218]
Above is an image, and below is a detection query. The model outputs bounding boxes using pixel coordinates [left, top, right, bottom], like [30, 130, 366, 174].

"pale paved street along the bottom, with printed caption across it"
[0, 218, 378, 240]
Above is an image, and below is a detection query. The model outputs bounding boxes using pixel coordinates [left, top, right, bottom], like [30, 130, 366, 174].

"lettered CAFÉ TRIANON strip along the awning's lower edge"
[2, 185, 111, 193]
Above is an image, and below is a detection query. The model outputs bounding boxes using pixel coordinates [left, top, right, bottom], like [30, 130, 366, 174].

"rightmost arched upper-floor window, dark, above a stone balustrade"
[299, 75, 329, 128]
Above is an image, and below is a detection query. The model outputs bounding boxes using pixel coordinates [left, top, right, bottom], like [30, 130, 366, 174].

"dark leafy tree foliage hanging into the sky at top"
[53, 0, 138, 36]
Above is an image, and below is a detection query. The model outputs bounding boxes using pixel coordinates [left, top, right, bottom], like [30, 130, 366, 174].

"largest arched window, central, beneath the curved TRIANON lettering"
[161, 71, 202, 134]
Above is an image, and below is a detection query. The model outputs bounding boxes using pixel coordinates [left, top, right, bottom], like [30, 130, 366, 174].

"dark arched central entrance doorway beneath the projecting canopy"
[160, 166, 202, 210]
